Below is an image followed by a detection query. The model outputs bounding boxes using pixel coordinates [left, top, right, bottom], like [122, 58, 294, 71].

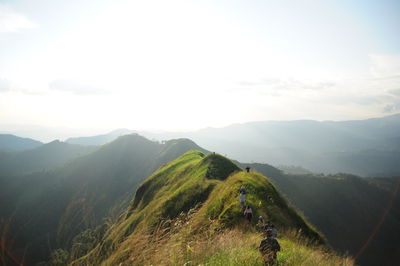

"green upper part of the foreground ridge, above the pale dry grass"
[72, 151, 340, 265]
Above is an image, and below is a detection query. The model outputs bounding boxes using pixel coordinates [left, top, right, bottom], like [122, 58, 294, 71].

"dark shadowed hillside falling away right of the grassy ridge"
[247, 164, 400, 265]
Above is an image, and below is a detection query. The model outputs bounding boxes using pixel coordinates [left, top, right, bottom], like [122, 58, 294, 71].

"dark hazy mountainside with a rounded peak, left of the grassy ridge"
[0, 134, 206, 264]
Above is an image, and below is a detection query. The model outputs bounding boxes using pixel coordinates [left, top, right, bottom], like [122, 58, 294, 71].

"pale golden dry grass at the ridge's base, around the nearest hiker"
[94, 214, 354, 266]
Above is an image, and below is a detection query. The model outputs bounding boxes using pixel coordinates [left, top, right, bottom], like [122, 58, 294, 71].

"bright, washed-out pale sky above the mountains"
[0, 0, 400, 140]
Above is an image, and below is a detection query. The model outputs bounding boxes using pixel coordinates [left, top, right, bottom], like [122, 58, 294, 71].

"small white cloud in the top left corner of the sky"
[0, 4, 37, 33]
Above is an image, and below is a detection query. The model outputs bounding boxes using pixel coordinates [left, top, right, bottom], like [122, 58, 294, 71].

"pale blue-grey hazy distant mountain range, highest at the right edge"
[61, 114, 400, 176]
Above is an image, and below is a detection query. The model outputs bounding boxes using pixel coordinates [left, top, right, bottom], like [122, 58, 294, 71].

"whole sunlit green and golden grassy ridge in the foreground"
[69, 151, 350, 265]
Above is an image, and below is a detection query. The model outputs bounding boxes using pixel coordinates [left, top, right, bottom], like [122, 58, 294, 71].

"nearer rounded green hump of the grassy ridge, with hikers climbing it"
[195, 171, 324, 244]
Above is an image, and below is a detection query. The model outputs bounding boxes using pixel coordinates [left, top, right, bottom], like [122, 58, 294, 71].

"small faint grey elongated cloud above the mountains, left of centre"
[49, 79, 105, 94]
